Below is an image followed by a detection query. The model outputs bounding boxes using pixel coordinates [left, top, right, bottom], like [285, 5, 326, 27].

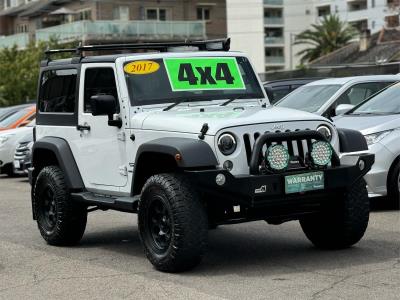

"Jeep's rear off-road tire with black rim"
[33, 166, 87, 246]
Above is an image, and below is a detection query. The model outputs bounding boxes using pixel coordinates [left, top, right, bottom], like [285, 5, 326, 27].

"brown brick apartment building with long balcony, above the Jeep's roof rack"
[0, 0, 227, 48]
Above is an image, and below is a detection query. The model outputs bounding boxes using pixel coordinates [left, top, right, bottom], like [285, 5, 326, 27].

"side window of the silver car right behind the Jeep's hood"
[337, 82, 393, 105]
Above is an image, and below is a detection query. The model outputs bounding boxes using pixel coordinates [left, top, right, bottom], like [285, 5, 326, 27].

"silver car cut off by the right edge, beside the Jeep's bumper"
[334, 83, 400, 208]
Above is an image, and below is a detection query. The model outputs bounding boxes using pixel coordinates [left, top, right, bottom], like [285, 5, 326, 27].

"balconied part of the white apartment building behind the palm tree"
[263, 0, 400, 71]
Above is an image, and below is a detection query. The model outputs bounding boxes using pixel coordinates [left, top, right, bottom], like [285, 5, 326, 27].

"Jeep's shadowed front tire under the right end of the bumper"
[300, 179, 369, 249]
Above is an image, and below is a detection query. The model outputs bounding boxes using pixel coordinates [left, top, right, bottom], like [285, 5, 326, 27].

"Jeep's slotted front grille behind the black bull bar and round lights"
[243, 129, 314, 164]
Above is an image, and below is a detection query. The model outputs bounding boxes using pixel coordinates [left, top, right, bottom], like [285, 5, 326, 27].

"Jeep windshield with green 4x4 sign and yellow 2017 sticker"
[124, 57, 264, 105]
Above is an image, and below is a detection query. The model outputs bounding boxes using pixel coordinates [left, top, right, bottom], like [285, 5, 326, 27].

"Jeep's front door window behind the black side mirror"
[84, 68, 118, 113]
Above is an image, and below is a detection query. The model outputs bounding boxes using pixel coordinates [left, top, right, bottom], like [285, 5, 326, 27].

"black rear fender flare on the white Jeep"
[32, 137, 85, 190]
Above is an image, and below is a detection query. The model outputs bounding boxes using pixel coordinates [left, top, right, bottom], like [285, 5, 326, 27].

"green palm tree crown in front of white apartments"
[294, 15, 357, 63]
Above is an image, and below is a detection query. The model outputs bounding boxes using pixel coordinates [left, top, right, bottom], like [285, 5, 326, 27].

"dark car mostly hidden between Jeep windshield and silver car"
[263, 78, 322, 104]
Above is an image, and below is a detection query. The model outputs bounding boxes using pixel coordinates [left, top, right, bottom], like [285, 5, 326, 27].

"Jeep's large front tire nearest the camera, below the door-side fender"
[138, 174, 208, 272]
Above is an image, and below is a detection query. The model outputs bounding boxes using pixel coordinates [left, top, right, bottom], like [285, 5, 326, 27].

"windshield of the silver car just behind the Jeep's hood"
[276, 84, 342, 112]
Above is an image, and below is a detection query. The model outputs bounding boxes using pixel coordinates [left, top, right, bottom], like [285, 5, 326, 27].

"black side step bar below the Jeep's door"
[71, 192, 140, 213]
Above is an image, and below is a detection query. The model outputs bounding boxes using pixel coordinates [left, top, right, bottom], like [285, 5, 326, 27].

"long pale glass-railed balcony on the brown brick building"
[36, 21, 206, 43]
